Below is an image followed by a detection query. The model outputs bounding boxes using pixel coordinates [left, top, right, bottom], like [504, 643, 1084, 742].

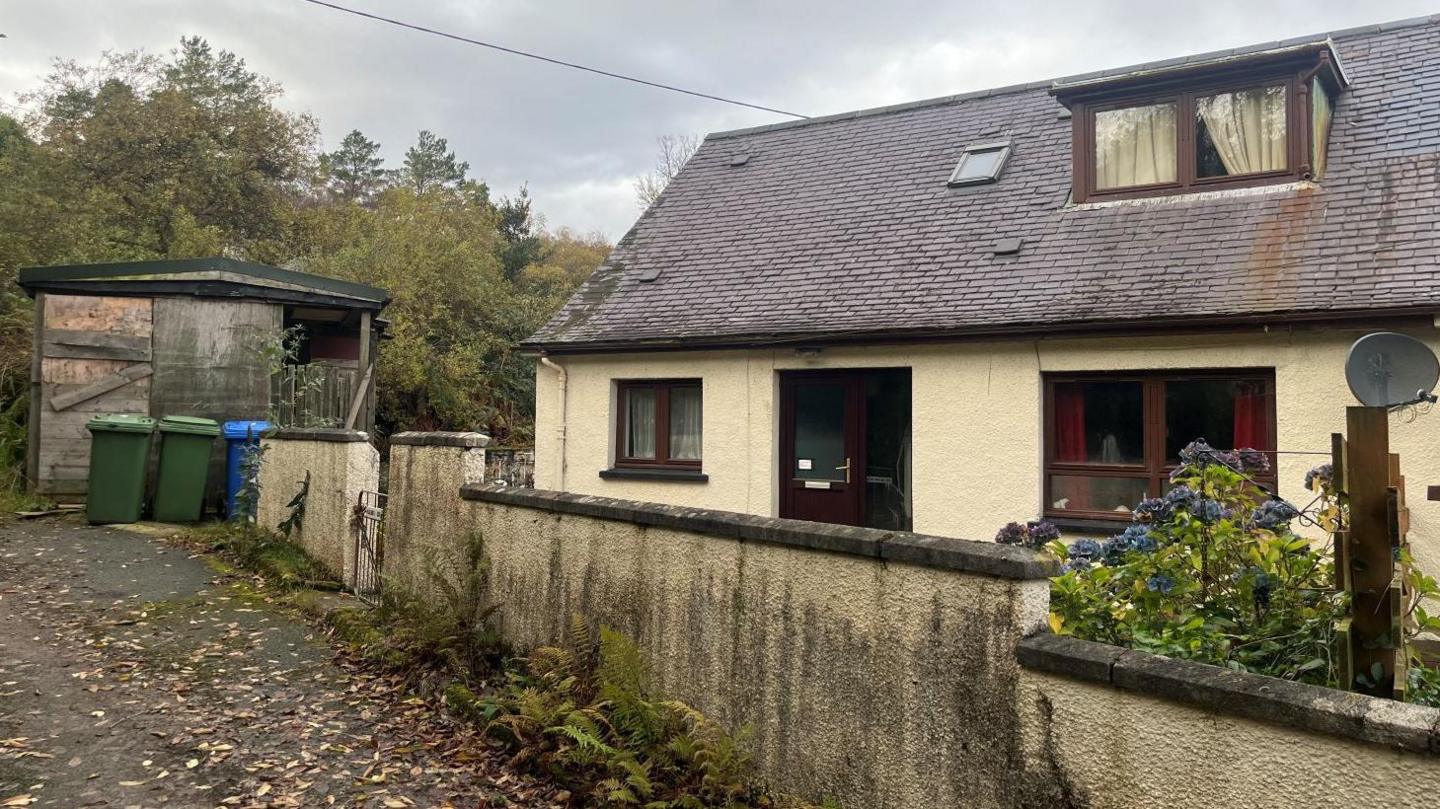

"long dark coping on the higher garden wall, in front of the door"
[459, 484, 1060, 580]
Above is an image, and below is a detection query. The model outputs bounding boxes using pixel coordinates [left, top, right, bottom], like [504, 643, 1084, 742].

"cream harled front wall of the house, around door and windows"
[536, 324, 1440, 571]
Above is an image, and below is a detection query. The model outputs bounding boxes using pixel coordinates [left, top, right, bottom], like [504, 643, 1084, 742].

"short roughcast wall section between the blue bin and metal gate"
[256, 429, 380, 582]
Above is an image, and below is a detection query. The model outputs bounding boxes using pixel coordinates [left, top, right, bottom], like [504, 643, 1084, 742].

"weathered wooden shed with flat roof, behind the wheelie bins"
[19, 258, 389, 500]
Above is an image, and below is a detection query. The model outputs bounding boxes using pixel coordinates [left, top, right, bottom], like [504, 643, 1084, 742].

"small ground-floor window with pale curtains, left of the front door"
[615, 379, 701, 469]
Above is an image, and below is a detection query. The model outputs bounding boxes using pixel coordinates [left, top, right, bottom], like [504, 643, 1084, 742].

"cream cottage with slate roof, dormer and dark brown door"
[527, 16, 1440, 570]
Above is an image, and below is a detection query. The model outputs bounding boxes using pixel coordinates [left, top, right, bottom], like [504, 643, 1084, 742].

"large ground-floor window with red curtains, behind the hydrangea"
[1044, 370, 1274, 520]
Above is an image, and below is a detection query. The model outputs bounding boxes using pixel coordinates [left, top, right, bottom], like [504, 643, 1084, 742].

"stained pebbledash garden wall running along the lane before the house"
[250, 433, 1440, 809]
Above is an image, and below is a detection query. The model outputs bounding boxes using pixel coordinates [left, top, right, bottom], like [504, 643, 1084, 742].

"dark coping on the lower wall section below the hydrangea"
[1018, 632, 1440, 753]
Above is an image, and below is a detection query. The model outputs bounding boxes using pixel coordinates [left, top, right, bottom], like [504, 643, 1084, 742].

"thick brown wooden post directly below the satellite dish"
[1345, 407, 1398, 695]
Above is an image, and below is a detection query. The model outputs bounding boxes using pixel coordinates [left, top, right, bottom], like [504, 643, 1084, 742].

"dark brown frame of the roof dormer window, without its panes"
[1051, 43, 1345, 203]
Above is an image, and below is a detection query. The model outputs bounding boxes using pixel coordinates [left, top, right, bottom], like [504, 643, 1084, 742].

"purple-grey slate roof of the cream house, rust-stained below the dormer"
[527, 14, 1440, 351]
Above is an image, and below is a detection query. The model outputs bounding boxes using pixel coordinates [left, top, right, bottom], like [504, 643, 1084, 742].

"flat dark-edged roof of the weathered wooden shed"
[19, 258, 390, 311]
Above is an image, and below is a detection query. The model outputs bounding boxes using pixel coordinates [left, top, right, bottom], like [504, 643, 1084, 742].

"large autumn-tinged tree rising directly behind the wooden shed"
[27, 37, 318, 261]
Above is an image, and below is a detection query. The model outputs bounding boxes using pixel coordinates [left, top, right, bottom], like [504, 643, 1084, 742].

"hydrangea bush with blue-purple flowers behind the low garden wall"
[1042, 440, 1346, 685]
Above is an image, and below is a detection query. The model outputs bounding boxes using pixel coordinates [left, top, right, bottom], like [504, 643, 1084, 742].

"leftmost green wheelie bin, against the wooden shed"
[85, 415, 156, 524]
